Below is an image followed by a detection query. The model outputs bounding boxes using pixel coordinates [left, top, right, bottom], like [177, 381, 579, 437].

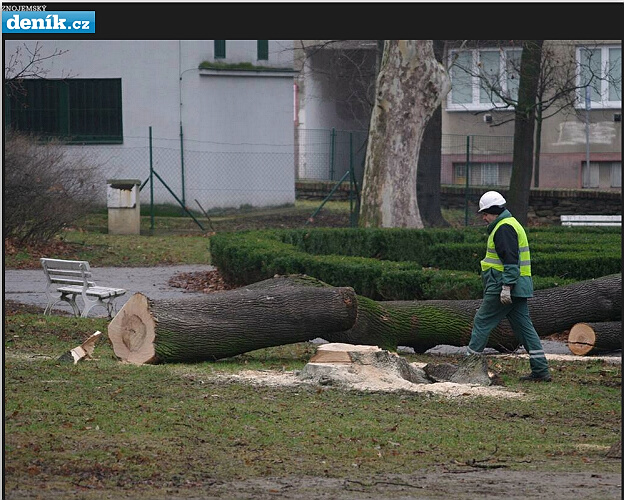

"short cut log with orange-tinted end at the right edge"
[568, 321, 622, 356]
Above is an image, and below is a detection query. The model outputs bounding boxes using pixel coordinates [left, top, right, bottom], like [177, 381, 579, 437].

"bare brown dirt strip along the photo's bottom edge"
[4, 468, 622, 500]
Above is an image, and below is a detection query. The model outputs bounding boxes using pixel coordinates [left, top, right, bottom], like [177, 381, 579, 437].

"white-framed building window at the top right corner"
[576, 46, 622, 108]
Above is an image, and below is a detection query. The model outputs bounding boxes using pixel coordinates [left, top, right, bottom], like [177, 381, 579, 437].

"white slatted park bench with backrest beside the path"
[40, 258, 126, 319]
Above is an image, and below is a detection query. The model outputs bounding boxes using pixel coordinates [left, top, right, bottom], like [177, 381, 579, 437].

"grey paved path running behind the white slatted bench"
[3, 264, 214, 316]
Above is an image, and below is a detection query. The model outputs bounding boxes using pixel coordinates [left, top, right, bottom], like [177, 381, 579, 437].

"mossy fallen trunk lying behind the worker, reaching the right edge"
[323, 274, 622, 352]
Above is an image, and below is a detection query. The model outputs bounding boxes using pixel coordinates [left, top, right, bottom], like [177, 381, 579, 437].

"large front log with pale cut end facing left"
[108, 278, 357, 364]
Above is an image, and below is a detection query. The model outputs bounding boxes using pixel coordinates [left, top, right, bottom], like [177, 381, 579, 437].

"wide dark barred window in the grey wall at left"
[4, 78, 123, 143]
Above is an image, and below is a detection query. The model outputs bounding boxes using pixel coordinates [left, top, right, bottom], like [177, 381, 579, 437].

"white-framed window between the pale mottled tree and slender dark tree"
[447, 48, 522, 110]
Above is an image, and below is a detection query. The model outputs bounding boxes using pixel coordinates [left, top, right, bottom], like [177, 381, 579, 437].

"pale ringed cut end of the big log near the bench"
[108, 293, 156, 365]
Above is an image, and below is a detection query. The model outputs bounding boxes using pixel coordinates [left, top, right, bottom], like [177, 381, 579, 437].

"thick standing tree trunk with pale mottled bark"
[359, 40, 449, 228]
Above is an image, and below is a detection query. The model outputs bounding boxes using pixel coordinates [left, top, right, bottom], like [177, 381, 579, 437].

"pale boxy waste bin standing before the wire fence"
[106, 179, 141, 234]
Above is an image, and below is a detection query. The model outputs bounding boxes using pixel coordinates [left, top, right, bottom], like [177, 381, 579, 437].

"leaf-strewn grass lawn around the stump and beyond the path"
[3, 204, 622, 499]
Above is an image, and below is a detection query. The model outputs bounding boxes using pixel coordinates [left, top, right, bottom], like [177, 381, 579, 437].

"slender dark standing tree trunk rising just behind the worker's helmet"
[507, 40, 544, 225]
